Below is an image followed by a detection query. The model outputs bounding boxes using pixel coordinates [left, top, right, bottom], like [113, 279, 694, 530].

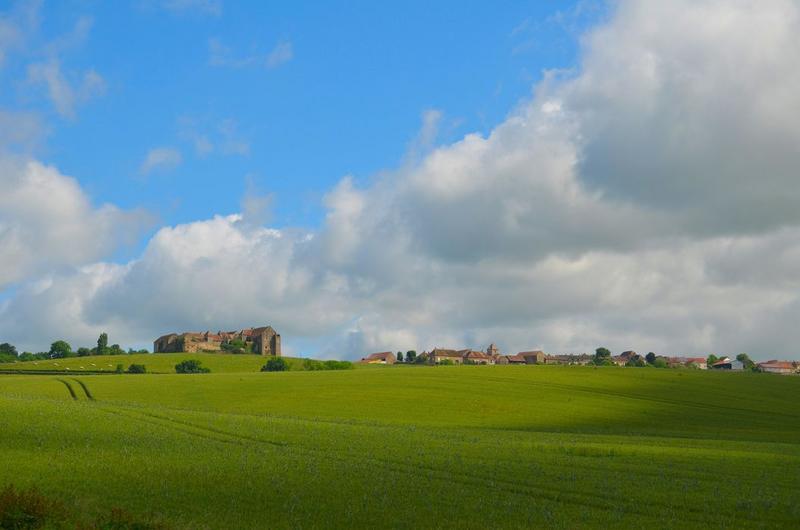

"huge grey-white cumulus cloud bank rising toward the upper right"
[0, 0, 800, 358]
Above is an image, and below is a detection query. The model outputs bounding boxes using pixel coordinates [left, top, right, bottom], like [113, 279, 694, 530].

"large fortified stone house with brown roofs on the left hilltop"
[153, 326, 281, 357]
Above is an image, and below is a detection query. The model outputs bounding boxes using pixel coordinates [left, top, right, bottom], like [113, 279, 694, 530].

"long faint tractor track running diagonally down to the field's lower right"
[89, 407, 780, 524]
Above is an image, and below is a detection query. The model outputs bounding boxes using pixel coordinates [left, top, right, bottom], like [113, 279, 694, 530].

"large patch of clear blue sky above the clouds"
[2, 1, 593, 243]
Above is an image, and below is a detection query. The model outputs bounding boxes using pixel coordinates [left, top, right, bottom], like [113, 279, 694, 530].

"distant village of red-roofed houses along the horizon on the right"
[360, 343, 800, 375]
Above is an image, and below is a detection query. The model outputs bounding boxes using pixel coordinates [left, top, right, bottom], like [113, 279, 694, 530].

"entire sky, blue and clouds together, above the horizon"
[0, 0, 800, 360]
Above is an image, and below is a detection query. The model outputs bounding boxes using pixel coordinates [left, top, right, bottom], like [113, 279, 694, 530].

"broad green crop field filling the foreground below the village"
[0, 366, 800, 529]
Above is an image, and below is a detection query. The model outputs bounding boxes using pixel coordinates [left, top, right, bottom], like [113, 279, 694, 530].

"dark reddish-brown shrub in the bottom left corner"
[0, 486, 66, 529]
